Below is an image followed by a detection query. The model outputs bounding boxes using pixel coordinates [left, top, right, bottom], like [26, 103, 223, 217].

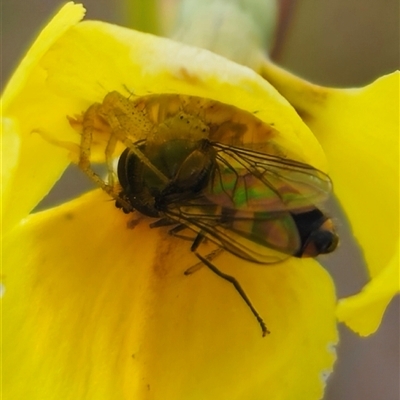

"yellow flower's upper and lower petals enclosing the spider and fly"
[2, 3, 398, 400]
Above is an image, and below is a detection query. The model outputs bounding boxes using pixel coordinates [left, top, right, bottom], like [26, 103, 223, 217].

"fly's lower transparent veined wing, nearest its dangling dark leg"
[165, 196, 301, 264]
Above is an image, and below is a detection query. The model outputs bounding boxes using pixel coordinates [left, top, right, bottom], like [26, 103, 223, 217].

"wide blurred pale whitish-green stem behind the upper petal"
[171, 0, 278, 71]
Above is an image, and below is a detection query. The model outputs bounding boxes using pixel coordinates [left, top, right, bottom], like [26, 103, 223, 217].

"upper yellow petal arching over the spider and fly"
[3, 3, 326, 234]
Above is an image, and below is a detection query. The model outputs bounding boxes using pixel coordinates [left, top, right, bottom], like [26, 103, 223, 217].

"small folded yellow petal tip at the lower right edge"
[337, 241, 400, 336]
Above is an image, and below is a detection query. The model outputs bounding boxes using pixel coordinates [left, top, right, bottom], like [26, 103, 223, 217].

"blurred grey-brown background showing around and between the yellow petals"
[1, 0, 400, 400]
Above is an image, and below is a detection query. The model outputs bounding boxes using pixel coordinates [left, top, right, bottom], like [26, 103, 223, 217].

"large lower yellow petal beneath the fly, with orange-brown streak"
[3, 191, 337, 400]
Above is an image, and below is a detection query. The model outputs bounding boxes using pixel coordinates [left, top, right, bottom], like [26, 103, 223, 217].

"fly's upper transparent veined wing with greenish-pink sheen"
[205, 143, 332, 212]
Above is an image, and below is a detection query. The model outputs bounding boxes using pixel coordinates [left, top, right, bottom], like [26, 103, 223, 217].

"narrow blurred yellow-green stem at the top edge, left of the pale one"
[124, 0, 160, 35]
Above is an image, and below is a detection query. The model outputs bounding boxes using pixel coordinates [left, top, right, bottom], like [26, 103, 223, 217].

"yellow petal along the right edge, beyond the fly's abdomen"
[263, 64, 400, 335]
